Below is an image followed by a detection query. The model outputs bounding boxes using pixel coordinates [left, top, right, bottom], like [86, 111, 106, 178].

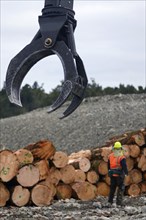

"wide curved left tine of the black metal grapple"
[6, 40, 53, 106]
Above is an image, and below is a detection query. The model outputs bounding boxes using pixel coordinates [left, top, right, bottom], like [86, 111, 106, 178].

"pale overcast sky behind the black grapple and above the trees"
[1, 0, 146, 92]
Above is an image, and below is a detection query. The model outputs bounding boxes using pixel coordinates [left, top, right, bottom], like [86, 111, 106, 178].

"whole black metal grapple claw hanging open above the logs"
[6, 0, 88, 118]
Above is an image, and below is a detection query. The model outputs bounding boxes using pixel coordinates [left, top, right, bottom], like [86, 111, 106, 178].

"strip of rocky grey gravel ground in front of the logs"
[0, 195, 146, 220]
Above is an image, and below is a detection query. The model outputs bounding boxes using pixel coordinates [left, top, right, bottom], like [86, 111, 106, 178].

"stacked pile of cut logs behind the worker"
[0, 129, 146, 207]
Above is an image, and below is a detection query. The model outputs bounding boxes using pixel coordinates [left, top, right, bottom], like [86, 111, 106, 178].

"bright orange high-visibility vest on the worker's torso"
[108, 153, 125, 176]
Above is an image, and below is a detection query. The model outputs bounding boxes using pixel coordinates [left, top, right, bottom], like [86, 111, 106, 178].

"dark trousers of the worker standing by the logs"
[108, 176, 125, 205]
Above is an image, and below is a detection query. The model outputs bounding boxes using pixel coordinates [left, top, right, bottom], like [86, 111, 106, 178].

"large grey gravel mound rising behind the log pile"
[0, 94, 146, 154]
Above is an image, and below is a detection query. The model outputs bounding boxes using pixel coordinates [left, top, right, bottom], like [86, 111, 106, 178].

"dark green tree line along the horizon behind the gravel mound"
[0, 79, 146, 118]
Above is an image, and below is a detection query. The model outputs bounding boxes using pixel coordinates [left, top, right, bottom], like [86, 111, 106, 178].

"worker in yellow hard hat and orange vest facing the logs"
[108, 141, 128, 207]
